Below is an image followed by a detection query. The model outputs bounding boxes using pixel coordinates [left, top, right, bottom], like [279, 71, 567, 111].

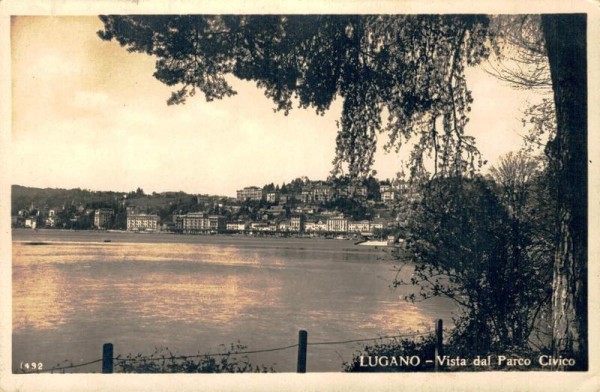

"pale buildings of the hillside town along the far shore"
[12, 177, 415, 238]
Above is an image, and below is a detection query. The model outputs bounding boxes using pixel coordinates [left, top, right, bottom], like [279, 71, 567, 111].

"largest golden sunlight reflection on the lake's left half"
[13, 244, 282, 330]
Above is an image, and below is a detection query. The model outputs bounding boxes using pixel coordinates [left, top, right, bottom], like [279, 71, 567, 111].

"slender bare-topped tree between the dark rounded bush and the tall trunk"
[490, 151, 558, 350]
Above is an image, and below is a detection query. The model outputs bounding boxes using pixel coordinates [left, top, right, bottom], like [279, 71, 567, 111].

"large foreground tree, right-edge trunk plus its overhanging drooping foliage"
[99, 14, 587, 368]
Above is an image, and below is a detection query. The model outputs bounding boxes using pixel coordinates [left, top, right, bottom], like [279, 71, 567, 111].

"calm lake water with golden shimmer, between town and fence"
[13, 229, 455, 372]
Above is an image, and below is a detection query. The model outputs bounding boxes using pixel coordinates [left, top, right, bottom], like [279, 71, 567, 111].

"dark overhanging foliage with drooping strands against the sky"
[99, 15, 489, 176]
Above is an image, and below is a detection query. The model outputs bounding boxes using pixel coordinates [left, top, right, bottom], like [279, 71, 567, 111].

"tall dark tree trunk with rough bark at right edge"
[542, 14, 588, 370]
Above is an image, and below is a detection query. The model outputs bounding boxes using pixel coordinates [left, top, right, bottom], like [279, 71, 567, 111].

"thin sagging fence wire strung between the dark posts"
[23, 331, 432, 374]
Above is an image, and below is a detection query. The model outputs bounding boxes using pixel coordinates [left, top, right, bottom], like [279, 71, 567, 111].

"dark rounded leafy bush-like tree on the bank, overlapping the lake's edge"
[395, 178, 549, 355]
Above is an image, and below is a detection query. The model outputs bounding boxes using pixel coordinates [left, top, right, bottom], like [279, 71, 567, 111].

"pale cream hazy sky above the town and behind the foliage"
[11, 17, 544, 196]
